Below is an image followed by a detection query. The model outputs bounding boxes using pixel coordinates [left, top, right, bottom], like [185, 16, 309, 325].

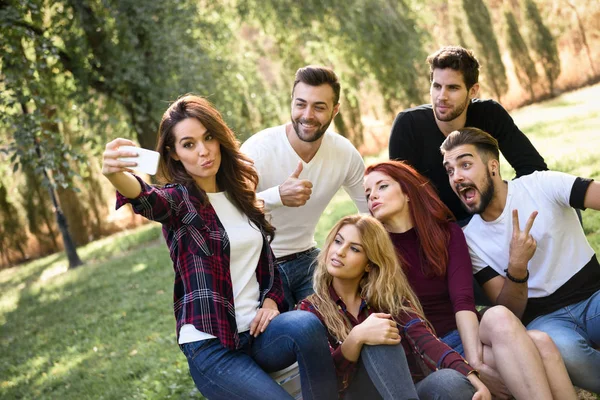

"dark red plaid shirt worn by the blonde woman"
[298, 286, 475, 397]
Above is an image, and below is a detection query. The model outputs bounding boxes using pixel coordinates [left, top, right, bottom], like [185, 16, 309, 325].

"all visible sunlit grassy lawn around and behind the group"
[0, 85, 600, 400]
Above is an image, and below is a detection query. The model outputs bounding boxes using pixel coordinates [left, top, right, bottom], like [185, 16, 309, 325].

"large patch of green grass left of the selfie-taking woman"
[0, 225, 202, 399]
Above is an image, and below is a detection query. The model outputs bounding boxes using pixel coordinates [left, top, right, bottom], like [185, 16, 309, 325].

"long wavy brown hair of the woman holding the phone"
[156, 95, 275, 239]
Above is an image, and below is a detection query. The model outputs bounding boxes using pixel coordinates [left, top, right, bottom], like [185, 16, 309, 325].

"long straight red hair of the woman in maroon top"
[365, 161, 455, 276]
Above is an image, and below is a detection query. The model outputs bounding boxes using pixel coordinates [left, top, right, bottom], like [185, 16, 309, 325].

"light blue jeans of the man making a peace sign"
[527, 291, 600, 393]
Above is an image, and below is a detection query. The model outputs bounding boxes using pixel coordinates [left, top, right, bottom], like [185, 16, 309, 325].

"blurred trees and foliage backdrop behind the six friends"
[0, 0, 600, 265]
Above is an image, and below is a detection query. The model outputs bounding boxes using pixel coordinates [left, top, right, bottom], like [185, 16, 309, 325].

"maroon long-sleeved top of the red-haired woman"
[390, 222, 477, 337]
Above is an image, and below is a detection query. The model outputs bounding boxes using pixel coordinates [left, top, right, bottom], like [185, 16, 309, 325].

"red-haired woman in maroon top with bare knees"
[365, 161, 576, 399]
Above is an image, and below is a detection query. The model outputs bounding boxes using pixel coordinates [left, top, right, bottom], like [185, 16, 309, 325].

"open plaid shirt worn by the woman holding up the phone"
[116, 176, 285, 349]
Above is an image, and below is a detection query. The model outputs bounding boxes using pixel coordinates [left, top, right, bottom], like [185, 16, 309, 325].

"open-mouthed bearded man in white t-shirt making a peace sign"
[441, 128, 600, 393]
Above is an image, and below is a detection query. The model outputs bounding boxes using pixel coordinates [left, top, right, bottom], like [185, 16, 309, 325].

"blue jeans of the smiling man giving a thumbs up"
[277, 249, 319, 310]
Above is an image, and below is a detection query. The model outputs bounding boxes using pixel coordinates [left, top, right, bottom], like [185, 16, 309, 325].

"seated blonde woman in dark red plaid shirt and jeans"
[298, 215, 491, 400]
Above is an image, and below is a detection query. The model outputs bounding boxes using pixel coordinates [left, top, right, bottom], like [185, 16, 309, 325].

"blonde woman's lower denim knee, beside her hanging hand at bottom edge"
[415, 369, 475, 400]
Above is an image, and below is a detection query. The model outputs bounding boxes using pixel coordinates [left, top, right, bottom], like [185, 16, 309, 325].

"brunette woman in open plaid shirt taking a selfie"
[102, 96, 336, 400]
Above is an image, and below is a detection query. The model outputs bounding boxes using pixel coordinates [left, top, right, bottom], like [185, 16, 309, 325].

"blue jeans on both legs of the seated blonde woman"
[344, 344, 475, 400]
